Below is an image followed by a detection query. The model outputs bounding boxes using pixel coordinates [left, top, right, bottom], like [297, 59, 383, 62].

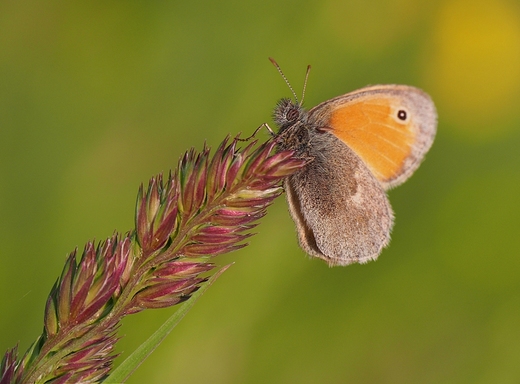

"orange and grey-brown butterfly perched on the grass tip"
[271, 59, 437, 266]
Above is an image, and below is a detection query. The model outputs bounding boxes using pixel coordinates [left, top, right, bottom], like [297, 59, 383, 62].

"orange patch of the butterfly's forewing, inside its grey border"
[327, 95, 416, 182]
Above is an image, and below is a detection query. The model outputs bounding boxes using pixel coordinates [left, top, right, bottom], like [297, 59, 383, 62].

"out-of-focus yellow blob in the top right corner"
[427, 0, 520, 140]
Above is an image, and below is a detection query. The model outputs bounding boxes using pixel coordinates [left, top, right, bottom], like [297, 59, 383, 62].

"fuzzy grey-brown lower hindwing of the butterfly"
[286, 138, 393, 265]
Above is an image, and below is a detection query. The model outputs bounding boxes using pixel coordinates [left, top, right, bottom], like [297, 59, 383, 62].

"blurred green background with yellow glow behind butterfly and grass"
[0, 0, 520, 383]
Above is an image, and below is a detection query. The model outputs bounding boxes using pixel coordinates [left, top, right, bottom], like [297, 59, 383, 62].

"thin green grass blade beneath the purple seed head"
[103, 264, 231, 384]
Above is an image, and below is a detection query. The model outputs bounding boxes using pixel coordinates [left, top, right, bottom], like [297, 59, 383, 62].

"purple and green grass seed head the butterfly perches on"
[0, 137, 304, 384]
